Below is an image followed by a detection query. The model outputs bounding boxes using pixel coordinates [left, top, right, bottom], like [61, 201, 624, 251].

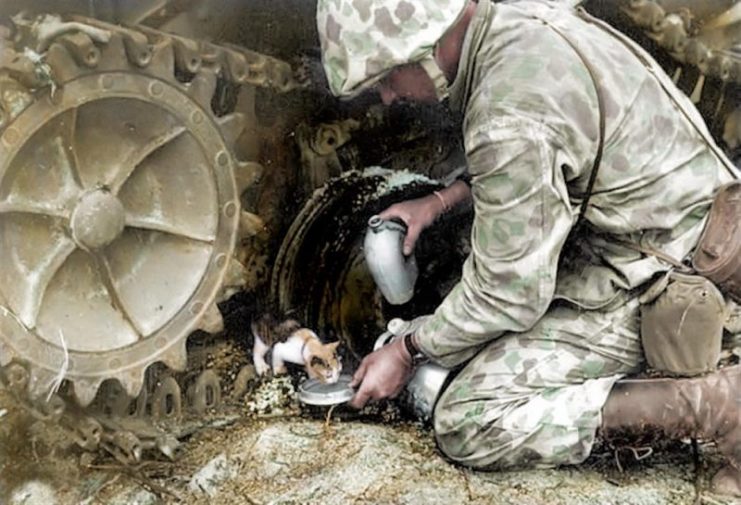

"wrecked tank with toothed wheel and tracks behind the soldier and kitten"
[0, 0, 741, 462]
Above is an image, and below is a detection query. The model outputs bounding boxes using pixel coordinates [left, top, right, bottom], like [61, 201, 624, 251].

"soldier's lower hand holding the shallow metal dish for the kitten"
[350, 332, 413, 409]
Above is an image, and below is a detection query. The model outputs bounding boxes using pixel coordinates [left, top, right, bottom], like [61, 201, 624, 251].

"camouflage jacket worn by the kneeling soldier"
[417, 0, 735, 366]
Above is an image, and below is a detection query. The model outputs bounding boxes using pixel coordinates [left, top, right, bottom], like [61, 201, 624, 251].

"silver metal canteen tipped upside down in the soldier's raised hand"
[363, 216, 419, 305]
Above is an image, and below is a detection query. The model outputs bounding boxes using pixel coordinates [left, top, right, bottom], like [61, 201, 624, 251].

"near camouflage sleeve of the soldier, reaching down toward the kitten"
[416, 119, 575, 367]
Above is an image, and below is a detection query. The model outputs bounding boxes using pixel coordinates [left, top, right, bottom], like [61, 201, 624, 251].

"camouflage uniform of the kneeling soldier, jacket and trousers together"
[320, 0, 733, 467]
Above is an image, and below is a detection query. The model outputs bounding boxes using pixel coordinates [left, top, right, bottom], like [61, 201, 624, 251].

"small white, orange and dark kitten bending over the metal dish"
[252, 314, 342, 384]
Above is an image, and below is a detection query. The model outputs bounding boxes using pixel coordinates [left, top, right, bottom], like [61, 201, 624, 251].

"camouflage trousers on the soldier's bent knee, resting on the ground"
[434, 297, 644, 469]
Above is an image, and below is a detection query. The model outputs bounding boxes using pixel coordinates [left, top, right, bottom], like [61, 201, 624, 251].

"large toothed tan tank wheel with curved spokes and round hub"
[0, 14, 262, 405]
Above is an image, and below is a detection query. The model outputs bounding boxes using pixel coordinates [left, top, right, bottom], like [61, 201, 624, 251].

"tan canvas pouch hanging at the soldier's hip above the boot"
[640, 270, 726, 376]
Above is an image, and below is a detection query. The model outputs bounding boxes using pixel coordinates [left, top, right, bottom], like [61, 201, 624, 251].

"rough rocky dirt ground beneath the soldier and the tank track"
[0, 378, 733, 505]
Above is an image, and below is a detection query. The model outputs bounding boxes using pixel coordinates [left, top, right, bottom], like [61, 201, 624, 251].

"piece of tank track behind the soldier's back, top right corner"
[596, 0, 741, 155]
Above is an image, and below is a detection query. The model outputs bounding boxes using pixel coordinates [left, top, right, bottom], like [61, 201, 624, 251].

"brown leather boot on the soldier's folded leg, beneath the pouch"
[601, 365, 741, 496]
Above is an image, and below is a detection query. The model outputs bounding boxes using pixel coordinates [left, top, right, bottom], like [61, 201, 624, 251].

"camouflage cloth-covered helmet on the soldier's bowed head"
[317, 0, 468, 97]
